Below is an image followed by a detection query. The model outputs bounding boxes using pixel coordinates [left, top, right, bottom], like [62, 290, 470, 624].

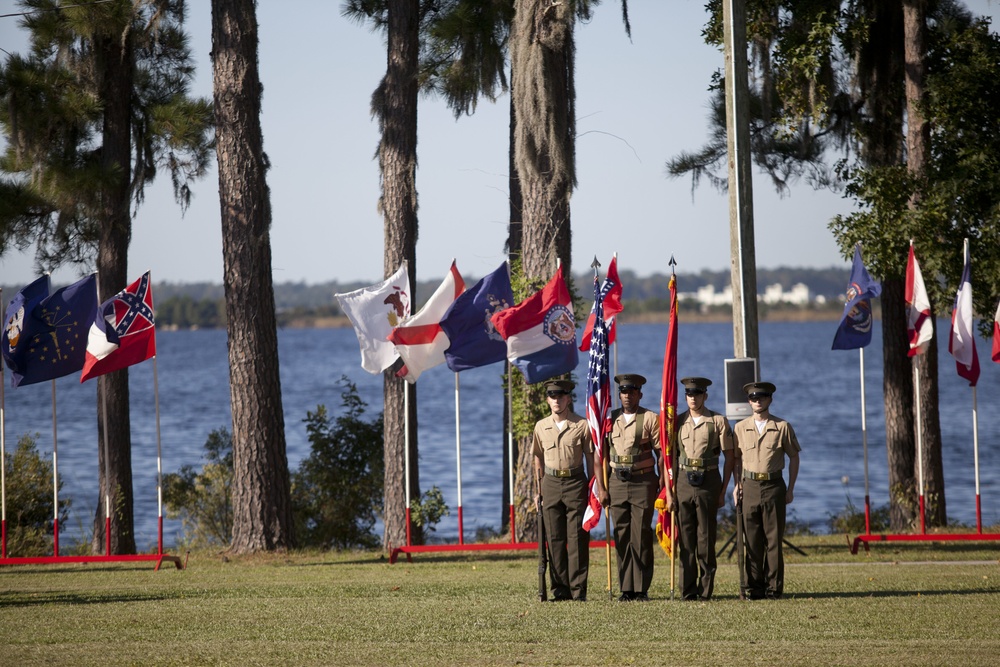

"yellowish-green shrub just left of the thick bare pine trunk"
[163, 428, 233, 547]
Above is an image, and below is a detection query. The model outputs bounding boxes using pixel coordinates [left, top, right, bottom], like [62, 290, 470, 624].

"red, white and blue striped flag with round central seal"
[492, 267, 580, 384]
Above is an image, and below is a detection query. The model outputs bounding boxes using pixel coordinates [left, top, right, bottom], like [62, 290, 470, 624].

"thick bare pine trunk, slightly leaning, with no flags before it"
[212, 0, 294, 554]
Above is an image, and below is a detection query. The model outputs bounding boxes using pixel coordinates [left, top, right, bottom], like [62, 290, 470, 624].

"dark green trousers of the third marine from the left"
[676, 468, 722, 600]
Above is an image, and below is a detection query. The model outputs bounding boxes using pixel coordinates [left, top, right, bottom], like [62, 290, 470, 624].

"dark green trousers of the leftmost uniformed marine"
[542, 472, 590, 600]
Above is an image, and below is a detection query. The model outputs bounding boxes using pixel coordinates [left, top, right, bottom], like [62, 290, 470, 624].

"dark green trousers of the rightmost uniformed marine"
[743, 477, 786, 600]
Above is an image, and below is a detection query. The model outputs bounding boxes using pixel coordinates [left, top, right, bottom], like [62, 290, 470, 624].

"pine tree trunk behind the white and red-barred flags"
[373, 0, 423, 549]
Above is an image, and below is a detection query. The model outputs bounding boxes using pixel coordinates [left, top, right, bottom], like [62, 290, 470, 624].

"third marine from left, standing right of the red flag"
[668, 377, 735, 600]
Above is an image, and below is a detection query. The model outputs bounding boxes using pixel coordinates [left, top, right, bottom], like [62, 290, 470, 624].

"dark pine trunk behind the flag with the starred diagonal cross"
[91, 31, 135, 554]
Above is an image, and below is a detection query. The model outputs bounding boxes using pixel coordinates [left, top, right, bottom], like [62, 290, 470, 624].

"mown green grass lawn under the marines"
[0, 536, 1000, 667]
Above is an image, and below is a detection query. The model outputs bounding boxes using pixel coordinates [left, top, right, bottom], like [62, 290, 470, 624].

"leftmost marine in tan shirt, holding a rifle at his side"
[532, 380, 594, 602]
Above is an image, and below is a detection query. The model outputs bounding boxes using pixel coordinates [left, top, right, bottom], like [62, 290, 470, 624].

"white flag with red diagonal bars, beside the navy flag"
[387, 260, 465, 384]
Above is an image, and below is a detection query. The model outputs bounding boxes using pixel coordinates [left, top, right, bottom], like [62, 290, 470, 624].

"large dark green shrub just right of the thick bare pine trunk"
[292, 376, 385, 549]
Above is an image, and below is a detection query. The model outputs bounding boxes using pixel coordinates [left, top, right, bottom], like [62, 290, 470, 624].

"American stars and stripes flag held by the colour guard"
[583, 276, 616, 530]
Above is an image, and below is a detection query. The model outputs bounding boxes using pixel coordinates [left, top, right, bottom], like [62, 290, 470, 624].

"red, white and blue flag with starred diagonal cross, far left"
[80, 271, 156, 382]
